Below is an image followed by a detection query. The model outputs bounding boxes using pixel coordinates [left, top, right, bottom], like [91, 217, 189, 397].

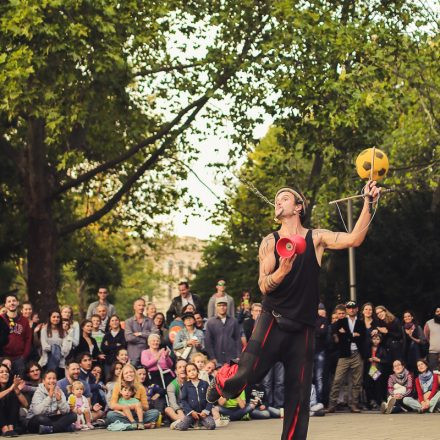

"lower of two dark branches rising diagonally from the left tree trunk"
[60, 96, 209, 236]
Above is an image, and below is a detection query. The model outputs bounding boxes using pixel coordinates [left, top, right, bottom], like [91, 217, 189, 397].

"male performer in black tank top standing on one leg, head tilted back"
[207, 181, 380, 440]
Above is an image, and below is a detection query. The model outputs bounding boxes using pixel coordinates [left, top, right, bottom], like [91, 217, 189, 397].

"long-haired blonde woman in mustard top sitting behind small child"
[107, 364, 159, 428]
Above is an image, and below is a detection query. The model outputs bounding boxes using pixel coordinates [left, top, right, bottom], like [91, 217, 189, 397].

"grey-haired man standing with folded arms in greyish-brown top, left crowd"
[125, 298, 152, 366]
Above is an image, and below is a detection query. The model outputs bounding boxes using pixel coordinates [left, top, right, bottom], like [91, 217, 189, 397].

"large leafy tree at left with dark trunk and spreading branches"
[0, 0, 274, 316]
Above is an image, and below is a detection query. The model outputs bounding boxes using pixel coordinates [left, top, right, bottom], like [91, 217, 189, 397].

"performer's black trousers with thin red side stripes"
[222, 311, 315, 440]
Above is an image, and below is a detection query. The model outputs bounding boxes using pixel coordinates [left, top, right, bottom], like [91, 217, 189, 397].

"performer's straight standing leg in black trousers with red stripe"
[279, 327, 315, 440]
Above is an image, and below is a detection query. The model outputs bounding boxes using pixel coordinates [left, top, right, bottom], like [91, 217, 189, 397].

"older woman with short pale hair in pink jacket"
[141, 333, 174, 387]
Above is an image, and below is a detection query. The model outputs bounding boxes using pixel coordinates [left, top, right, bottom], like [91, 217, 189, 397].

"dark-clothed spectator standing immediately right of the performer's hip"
[313, 303, 328, 403]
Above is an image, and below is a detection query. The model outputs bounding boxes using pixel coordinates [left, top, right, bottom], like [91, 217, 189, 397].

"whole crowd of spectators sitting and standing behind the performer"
[0, 280, 440, 437]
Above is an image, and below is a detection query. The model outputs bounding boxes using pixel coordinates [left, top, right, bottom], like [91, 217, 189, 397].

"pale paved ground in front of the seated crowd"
[21, 413, 440, 440]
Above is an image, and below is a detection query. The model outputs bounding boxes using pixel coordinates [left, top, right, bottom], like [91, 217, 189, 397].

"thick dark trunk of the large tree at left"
[24, 118, 58, 319]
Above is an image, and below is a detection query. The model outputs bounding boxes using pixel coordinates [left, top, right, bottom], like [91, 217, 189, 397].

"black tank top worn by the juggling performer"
[263, 229, 320, 326]
